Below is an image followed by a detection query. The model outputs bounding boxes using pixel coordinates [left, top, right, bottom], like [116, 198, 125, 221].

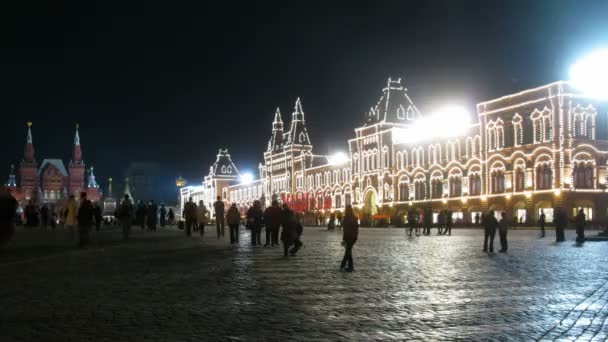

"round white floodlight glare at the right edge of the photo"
[570, 49, 608, 100]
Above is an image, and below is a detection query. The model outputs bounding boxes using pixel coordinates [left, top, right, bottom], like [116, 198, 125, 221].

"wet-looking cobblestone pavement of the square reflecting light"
[0, 227, 608, 341]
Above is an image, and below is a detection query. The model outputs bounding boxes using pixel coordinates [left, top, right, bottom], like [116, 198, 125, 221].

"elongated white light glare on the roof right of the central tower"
[395, 106, 471, 143]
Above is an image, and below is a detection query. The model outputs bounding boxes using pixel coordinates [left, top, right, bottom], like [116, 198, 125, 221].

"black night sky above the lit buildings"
[0, 0, 608, 187]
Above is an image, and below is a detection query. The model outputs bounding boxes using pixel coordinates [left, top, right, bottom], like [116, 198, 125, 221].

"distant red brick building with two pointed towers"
[7, 122, 102, 205]
